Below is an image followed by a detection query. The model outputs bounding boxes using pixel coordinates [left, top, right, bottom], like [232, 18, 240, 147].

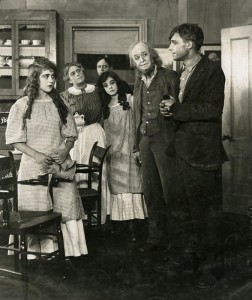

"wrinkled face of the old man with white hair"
[131, 43, 152, 73]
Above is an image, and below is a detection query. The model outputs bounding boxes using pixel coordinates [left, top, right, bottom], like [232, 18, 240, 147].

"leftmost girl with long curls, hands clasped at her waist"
[6, 57, 87, 259]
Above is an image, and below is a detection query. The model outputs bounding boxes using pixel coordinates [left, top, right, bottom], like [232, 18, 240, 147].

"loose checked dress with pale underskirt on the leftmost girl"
[6, 97, 87, 256]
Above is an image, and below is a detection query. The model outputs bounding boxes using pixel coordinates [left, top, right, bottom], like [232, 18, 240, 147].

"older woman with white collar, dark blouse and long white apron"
[61, 62, 110, 224]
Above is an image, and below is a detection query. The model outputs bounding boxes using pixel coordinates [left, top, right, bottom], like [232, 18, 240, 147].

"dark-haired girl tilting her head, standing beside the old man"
[97, 71, 146, 239]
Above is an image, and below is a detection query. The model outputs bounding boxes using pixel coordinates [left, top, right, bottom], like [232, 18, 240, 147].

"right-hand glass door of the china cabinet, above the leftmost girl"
[17, 22, 48, 94]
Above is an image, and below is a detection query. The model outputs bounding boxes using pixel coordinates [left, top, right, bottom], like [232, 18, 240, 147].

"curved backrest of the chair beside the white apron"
[88, 142, 110, 193]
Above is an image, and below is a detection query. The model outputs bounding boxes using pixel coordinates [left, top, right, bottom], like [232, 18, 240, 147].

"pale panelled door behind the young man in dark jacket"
[221, 25, 252, 214]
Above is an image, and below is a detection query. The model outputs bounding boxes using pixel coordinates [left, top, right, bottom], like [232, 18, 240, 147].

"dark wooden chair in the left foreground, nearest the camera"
[0, 152, 65, 299]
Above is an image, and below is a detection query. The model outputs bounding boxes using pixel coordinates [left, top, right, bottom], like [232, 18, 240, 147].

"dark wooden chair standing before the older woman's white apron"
[76, 142, 110, 229]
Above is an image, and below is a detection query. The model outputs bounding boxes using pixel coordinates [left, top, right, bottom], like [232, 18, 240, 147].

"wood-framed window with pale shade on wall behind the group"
[64, 19, 147, 86]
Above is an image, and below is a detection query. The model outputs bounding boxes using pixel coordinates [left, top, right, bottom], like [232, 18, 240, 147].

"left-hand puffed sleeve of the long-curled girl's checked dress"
[5, 99, 27, 144]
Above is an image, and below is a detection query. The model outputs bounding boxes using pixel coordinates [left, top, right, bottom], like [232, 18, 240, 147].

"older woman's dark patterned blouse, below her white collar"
[60, 89, 102, 125]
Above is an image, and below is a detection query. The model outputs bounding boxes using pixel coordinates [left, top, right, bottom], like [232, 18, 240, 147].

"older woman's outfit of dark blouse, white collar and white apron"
[60, 84, 110, 224]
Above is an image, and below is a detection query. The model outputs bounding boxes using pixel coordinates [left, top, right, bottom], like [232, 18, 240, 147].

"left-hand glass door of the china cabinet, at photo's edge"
[0, 22, 15, 95]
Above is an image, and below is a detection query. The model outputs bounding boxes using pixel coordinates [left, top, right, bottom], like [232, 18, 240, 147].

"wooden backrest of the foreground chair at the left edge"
[0, 151, 18, 225]
